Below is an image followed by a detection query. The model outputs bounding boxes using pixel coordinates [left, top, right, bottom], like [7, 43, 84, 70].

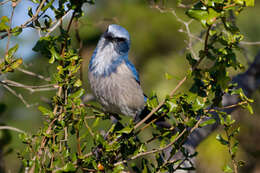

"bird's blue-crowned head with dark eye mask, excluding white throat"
[101, 24, 130, 55]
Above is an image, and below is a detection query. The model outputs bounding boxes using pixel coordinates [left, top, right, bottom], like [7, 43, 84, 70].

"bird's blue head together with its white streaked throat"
[89, 24, 130, 76]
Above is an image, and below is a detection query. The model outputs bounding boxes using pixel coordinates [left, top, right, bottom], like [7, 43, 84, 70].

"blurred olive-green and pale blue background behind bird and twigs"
[0, 0, 260, 173]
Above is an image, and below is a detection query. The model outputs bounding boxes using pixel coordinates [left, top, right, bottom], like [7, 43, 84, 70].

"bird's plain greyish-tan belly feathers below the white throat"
[89, 63, 145, 116]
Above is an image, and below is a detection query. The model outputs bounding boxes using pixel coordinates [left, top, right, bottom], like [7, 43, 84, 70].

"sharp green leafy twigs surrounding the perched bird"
[0, 0, 254, 172]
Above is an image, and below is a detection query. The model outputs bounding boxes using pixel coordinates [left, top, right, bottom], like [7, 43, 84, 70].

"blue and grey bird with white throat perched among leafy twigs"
[88, 24, 171, 127]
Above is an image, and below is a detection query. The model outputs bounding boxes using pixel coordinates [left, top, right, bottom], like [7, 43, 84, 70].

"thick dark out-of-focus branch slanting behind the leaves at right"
[169, 51, 260, 173]
